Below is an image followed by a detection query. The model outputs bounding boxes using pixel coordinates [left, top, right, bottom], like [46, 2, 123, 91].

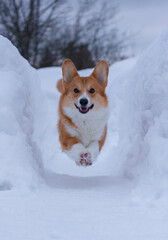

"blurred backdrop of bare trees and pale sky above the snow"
[0, 0, 168, 70]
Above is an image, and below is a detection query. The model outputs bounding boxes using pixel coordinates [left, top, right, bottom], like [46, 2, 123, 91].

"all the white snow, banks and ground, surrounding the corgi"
[0, 32, 168, 240]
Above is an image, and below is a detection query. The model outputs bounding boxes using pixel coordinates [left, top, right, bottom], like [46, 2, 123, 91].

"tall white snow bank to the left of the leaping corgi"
[0, 36, 43, 189]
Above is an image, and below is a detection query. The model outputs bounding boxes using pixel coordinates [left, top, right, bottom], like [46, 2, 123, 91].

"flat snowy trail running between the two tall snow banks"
[0, 61, 168, 240]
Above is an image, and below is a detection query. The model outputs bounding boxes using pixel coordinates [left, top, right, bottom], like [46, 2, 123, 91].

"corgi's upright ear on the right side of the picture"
[91, 60, 109, 87]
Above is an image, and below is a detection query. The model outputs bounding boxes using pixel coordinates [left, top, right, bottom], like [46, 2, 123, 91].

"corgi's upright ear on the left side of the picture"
[62, 59, 79, 83]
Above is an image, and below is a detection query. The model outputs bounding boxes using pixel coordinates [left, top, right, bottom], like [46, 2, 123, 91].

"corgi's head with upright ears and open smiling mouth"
[57, 59, 108, 115]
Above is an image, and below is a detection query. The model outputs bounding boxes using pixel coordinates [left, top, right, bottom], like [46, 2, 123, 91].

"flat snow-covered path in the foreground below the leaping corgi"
[0, 181, 168, 240]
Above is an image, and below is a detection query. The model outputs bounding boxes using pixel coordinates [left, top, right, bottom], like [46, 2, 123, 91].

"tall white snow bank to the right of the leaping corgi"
[112, 32, 168, 192]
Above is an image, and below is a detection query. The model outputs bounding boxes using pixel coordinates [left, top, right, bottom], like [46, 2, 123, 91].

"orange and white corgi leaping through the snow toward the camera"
[57, 59, 109, 166]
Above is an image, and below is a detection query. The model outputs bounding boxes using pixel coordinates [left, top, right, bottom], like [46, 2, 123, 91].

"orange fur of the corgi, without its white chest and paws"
[57, 59, 108, 166]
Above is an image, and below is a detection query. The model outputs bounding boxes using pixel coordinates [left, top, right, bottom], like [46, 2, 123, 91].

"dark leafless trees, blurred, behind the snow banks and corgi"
[0, 0, 129, 69]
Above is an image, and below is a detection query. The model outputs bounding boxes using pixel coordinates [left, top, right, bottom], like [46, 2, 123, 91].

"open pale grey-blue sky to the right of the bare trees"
[118, 0, 168, 54]
